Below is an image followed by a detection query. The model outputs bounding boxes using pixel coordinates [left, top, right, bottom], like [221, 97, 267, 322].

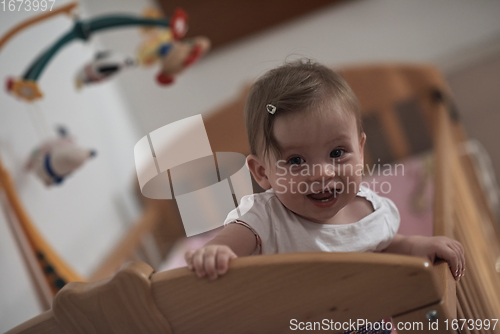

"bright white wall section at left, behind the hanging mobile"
[0, 0, 141, 333]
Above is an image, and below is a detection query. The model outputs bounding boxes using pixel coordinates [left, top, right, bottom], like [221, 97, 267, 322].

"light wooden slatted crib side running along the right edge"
[434, 90, 500, 333]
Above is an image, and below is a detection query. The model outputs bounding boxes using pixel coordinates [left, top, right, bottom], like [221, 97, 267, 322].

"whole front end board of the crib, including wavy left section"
[7, 253, 454, 334]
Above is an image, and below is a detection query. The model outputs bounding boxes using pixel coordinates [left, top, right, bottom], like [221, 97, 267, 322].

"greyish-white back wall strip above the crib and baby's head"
[86, 0, 500, 133]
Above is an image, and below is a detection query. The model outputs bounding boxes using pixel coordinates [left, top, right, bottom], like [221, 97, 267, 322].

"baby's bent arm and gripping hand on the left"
[184, 224, 257, 280]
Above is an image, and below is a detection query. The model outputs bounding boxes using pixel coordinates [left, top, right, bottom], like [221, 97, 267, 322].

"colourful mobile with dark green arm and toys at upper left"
[0, 3, 210, 101]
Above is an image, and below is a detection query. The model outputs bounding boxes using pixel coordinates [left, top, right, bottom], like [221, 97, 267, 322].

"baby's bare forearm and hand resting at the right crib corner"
[382, 234, 465, 280]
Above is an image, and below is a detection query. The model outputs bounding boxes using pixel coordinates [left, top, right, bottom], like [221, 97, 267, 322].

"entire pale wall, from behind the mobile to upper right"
[0, 0, 500, 330]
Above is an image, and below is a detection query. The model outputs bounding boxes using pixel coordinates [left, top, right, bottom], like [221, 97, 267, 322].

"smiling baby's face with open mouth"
[265, 106, 365, 224]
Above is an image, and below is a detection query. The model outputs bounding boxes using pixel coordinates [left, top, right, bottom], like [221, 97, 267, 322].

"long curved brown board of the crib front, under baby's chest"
[151, 253, 442, 334]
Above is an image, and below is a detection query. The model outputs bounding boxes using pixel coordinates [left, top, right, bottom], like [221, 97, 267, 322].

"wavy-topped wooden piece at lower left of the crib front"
[4, 262, 172, 334]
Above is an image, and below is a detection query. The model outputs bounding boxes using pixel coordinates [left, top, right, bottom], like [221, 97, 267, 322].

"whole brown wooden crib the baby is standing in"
[4, 65, 500, 334]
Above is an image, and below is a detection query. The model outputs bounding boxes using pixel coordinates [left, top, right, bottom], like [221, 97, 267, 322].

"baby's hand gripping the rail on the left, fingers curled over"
[184, 245, 237, 280]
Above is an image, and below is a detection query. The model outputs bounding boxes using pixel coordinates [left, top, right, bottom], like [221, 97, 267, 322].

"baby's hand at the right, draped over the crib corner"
[411, 237, 465, 281]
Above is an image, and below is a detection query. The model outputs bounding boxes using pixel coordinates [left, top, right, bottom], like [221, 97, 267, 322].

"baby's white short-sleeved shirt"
[224, 186, 400, 254]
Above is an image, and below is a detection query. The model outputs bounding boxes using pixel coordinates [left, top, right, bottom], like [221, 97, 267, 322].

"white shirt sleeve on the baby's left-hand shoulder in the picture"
[224, 194, 272, 254]
